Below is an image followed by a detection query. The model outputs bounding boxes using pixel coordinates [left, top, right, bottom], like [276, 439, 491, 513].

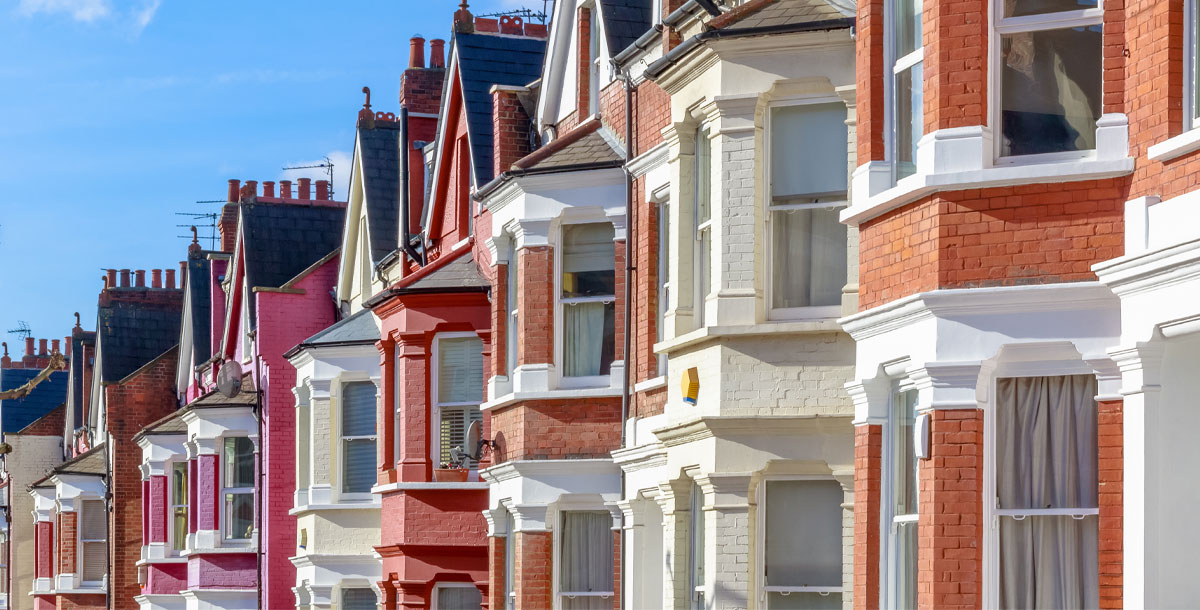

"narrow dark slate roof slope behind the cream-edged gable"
[358, 121, 400, 263]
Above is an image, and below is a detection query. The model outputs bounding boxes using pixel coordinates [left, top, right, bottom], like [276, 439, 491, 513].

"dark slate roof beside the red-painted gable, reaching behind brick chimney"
[452, 34, 546, 185]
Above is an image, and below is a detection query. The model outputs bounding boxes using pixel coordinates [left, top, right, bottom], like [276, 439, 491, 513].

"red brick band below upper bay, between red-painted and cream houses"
[492, 397, 620, 464]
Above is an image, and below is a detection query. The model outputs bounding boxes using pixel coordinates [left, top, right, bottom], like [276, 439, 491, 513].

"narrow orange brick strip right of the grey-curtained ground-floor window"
[1097, 400, 1124, 609]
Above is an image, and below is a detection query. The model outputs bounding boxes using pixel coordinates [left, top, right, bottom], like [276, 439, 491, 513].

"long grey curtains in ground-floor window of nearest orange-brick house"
[996, 375, 1099, 608]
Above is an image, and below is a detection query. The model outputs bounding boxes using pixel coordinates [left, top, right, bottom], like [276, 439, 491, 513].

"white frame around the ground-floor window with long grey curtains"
[983, 358, 1099, 608]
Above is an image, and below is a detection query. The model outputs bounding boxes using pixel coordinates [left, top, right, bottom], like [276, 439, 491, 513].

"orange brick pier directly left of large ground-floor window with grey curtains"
[916, 409, 983, 609]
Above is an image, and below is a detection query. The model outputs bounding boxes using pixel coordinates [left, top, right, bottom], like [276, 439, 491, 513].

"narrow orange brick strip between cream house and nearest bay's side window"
[853, 424, 883, 609]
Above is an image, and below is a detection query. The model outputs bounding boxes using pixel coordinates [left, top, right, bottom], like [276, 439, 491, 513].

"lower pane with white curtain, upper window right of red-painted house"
[563, 301, 617, 377]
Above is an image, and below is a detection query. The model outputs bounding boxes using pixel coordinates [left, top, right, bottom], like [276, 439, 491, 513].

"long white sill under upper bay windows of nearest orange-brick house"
[841, 157, 1134, 226]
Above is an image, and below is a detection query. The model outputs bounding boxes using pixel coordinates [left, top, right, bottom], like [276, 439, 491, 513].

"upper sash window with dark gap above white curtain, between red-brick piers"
[560, 222, 617, 377]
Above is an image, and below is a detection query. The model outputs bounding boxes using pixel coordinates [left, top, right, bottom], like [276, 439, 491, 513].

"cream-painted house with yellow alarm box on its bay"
[613, 0, 858, 609]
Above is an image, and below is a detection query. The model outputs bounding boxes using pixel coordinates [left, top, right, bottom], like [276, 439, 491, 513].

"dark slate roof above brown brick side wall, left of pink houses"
[96, 300, 182, 383]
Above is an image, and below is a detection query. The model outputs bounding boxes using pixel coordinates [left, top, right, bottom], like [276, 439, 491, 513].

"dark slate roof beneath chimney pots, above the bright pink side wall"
[241, 203, 346, 288]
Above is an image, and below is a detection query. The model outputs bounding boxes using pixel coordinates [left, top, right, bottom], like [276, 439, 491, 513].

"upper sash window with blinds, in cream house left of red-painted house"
[342, 382, 378, 494]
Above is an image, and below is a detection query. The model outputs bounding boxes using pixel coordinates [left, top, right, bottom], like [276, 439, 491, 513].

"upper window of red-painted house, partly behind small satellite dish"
[436, 335, 484, 467]
